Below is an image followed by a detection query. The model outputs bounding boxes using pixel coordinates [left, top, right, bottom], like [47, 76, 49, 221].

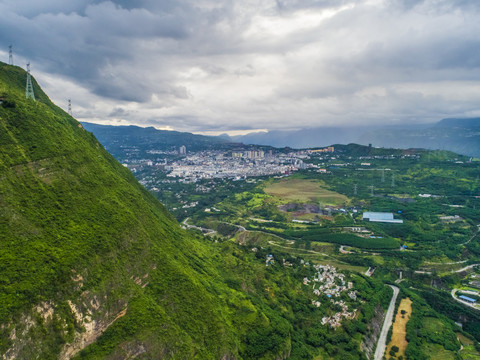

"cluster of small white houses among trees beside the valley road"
[303, 265, 357, 328]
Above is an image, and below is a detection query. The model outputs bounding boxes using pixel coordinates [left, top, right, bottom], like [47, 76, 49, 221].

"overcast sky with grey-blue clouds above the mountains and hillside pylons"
[0, 0, 480, 135]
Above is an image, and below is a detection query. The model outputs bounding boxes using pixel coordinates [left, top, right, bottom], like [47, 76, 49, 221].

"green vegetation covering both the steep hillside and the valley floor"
[0, 63, 480, 359]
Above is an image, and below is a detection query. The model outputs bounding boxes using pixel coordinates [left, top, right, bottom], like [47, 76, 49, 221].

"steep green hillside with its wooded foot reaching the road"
[0, 63, 404, 360]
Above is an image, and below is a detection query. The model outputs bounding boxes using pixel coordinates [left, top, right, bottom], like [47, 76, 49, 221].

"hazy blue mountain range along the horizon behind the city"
[83, 118, 480, 157]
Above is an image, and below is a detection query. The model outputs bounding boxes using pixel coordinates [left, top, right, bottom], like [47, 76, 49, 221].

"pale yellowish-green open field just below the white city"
[264, 178, 349, 206]
